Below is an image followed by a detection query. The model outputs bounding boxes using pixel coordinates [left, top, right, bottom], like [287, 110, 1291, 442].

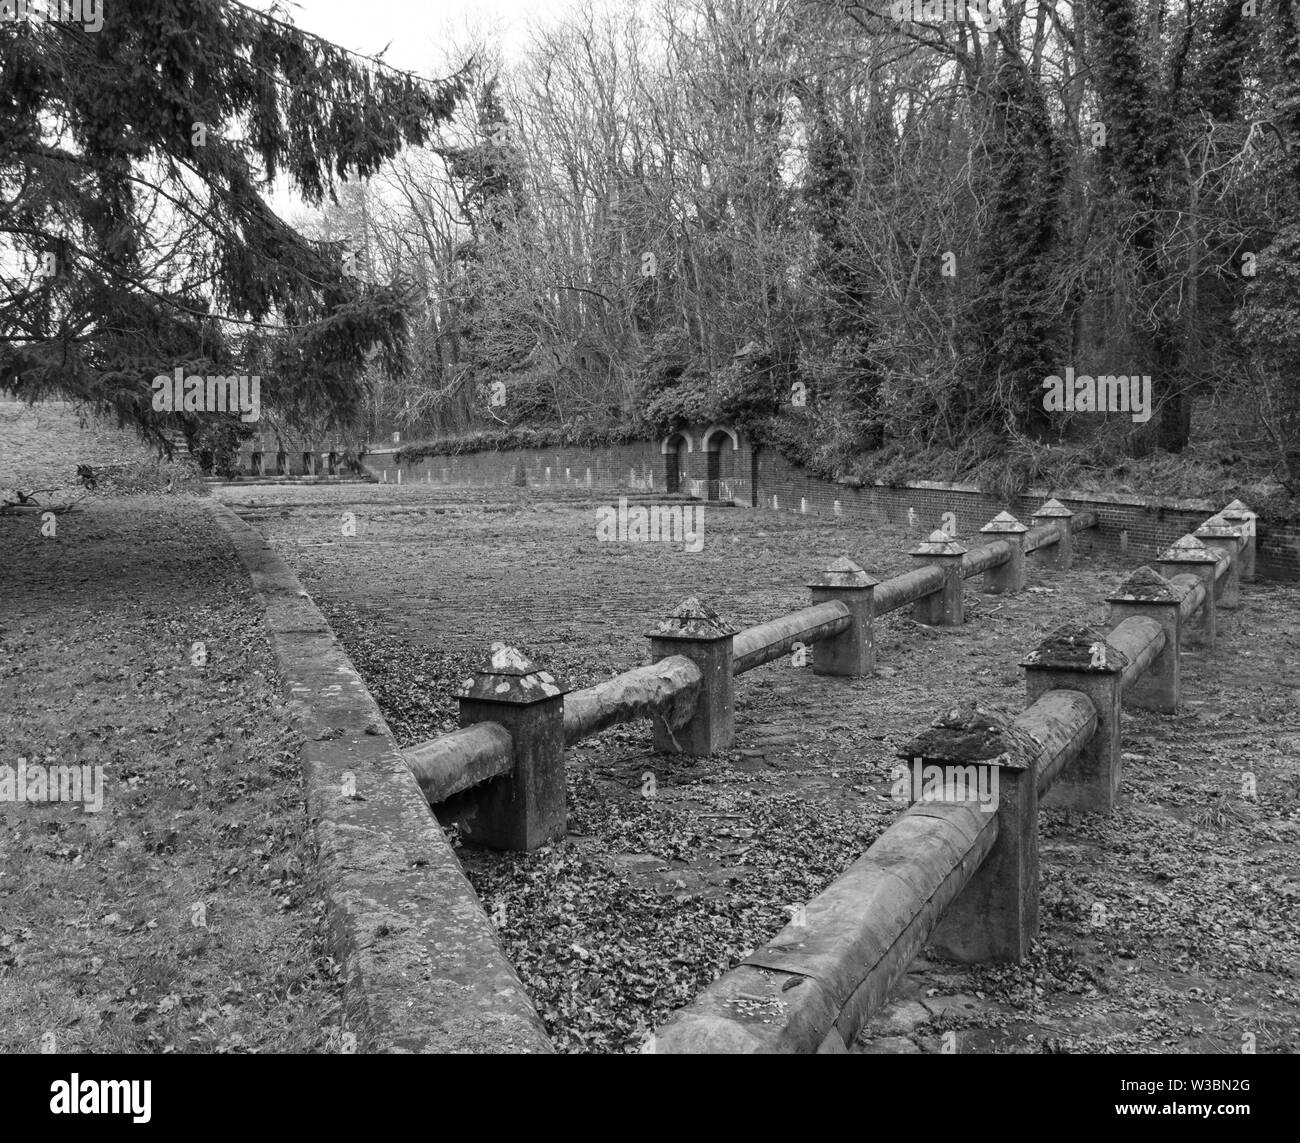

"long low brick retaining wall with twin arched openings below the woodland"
[365, 427, 1300, 579]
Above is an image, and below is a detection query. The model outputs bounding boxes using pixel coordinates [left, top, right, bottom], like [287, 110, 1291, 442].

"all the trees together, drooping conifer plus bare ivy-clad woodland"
[0, 0, 1300, 498]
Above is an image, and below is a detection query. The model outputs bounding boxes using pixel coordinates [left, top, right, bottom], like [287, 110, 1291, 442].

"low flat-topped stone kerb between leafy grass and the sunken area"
[208, 502, 554, 1053]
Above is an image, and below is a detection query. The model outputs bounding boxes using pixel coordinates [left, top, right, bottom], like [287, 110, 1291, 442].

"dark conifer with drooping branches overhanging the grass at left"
[0, 0, 463, 441]
